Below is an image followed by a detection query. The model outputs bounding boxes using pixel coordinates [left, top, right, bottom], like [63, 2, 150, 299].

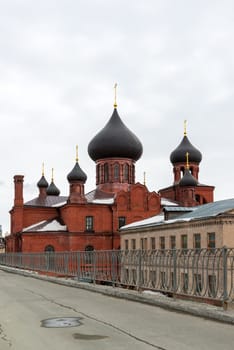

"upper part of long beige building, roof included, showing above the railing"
[121, 199, 234, 250]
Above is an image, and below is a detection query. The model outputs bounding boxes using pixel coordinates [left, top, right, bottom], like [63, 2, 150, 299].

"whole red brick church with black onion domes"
[6, 104, 214, 252]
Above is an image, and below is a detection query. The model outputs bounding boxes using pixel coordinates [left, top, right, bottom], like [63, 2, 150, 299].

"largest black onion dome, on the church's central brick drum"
[88, 108, 143, 161]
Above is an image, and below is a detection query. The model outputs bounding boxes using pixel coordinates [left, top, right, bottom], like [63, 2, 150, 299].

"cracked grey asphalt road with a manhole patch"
[0, 271, 234, 350]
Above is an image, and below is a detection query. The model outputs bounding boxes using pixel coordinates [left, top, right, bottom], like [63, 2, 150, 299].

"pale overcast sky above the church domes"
[0, 0, 234, 232]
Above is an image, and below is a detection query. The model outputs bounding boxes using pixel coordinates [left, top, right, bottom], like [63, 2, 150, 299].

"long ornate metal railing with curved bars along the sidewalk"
[0, 247, 234, 301]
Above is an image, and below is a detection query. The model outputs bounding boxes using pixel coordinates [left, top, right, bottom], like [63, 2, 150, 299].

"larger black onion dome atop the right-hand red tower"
[170, 135, 202, 164]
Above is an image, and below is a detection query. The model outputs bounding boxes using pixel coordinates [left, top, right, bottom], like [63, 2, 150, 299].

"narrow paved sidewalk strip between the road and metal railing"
[0, 266, 234, 325]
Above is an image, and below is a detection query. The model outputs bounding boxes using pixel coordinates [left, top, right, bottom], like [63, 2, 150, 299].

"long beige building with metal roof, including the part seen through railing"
[121, 199, 234, 300]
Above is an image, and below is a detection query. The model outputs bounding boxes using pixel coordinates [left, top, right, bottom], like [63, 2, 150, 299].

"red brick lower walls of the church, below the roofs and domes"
[8, 178, 161, 252]
